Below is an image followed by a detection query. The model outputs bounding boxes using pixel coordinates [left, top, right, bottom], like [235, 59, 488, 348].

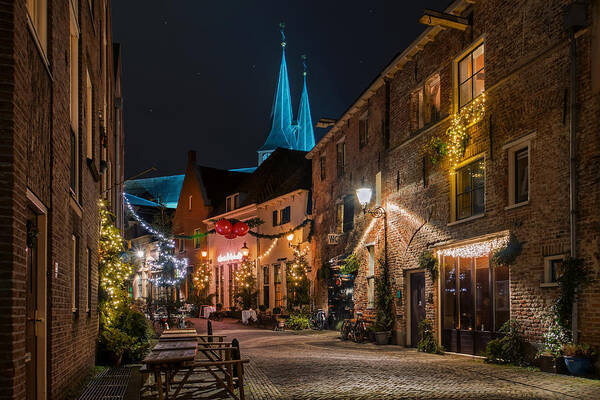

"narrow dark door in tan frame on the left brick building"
[25, 208, 39, 400]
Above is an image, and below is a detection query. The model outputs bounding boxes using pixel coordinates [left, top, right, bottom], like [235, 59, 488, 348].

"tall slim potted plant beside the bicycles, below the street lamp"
[374, 260, 394, 345]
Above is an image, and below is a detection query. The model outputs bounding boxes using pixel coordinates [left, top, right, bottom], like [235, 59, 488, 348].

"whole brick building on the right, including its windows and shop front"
[308, 0, 600, 354]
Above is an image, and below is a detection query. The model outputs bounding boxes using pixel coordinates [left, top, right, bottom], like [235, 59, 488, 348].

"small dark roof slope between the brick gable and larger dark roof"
[196, 165, 250, 206]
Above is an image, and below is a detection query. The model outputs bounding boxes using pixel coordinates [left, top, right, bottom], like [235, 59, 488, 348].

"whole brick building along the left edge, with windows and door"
[0, 0, 123, 399]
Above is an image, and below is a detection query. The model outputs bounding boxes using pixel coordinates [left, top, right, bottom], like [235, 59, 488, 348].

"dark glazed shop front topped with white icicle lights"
[437, 236, 510, 355]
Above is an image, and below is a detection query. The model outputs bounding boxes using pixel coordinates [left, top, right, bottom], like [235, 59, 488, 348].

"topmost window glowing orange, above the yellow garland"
[458, 44, 485, 108]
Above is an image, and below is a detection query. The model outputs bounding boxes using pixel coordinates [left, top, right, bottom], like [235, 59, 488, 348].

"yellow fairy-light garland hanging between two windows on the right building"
[446, 93, 485, 169]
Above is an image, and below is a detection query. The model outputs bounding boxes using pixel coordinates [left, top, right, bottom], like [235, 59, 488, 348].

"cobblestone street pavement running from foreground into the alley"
[189, 320, 600, 400]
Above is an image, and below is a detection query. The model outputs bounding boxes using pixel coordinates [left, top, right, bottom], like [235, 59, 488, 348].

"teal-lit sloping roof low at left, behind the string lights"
[123, 175, 185, 208]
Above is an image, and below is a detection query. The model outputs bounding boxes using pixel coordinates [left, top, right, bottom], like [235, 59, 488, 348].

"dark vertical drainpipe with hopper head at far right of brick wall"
[565, 1, 587, 343]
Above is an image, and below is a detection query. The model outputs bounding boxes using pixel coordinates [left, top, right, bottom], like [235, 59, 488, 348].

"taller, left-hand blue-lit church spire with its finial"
[258, 23, 296, 165]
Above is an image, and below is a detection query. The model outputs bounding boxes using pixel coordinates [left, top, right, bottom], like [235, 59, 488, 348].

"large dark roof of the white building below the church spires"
[215, 148, 312, 215]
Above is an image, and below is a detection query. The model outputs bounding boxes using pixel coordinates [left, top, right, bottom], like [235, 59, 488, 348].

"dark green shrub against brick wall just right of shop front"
[485, 319, 525, 365]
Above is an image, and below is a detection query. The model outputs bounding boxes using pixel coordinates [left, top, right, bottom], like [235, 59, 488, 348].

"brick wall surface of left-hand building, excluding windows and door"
[0, 0, 122, 399]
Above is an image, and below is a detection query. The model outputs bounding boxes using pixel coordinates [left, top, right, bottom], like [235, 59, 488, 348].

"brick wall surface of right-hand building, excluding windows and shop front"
[309, 0, 600, 344]
